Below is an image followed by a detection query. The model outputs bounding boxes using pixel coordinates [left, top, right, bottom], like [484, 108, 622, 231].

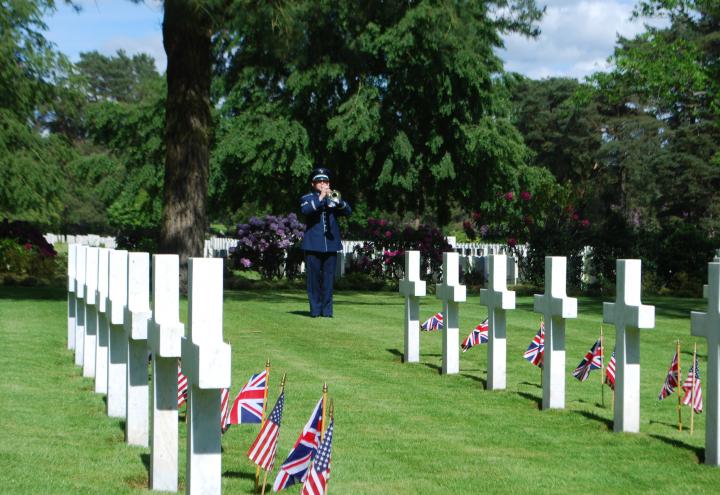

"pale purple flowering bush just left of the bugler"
[230, 213, 305, 280]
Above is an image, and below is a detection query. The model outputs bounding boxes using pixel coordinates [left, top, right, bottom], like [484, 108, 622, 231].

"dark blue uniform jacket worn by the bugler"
[300, 191, 352, 253]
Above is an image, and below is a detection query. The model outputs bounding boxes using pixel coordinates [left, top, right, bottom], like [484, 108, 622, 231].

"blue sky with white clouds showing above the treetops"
[46, 0, 662, 79]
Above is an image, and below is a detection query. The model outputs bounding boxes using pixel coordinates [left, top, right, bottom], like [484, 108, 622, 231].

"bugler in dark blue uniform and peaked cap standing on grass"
[300, 168, 352, 318]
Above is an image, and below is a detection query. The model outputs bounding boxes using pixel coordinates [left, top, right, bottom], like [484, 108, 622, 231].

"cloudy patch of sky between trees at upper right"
[498, 0, 663, 79]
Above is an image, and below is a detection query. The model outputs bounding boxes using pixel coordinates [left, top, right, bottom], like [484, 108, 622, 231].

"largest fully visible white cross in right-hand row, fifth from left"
[600, 260, 655, 433]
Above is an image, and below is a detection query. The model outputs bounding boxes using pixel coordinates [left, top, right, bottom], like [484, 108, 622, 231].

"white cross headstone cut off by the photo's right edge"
[690, 262, 720, 466]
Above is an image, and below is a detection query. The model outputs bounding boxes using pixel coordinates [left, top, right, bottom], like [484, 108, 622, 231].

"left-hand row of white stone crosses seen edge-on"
[68, 244, 230, 494]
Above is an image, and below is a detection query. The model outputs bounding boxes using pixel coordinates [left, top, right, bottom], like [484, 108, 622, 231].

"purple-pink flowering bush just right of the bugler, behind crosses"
[348, 218, 451, 280]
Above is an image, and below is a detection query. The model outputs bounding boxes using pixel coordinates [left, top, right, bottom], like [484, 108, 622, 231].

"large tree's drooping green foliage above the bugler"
[221, 1, 540, 223]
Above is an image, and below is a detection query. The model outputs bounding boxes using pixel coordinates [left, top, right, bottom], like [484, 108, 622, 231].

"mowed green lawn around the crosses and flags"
[0, 287, 720, 495]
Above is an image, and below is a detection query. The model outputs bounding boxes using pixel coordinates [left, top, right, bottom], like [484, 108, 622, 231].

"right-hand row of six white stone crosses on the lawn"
[400, 251, 720, 465]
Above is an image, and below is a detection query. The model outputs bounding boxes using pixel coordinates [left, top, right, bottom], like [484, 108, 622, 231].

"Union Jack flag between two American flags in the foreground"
[273, 398, 323, 492]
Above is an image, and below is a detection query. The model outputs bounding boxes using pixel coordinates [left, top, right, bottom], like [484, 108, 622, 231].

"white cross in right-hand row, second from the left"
[435, 253, 465, 375]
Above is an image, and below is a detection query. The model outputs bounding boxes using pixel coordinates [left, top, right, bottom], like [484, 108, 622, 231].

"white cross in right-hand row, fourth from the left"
[534, 256, 577, 409]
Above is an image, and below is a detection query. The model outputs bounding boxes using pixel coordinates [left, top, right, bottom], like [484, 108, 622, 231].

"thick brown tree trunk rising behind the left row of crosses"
[160, 0, 212, 289]
